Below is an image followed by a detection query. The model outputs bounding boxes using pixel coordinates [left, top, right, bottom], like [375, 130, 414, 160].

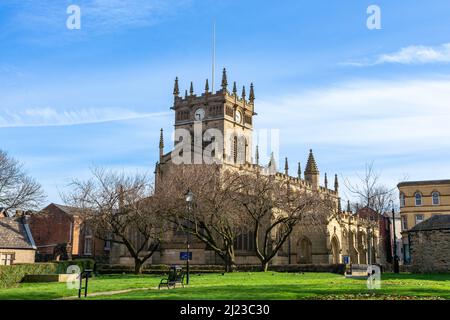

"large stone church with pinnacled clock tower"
[111, 69, 380, 265]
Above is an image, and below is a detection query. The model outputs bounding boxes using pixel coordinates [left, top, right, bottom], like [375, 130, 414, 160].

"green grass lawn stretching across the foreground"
[0, 272, 450, 300]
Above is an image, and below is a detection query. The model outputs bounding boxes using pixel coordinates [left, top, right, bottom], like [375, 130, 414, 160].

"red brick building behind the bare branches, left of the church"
[29, 203, 110, 260]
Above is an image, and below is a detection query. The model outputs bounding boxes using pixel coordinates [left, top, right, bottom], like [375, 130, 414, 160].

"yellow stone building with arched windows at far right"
[397, 180, 450, 264]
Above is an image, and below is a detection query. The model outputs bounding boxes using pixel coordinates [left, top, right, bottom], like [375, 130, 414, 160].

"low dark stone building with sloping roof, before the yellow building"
[408, 215, 450, 272]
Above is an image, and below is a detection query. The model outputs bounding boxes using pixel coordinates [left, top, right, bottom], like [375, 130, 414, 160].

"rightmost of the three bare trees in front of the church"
[235, 173, 332, 271]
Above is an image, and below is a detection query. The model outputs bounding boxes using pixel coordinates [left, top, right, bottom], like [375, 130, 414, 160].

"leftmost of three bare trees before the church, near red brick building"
[64, 168, 165, 274]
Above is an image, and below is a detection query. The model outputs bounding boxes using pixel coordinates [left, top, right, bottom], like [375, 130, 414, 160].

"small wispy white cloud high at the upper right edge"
[341, 43, 450, 67]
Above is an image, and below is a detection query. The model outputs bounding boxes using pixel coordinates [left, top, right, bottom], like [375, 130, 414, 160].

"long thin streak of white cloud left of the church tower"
[0, 107, 167, 128]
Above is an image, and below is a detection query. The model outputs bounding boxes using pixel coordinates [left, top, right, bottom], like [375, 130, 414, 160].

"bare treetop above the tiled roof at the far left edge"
[0, 150, 45, 210]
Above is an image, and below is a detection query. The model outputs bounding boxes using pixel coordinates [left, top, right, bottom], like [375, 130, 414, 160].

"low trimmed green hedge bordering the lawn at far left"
[0, 259, 95, 288]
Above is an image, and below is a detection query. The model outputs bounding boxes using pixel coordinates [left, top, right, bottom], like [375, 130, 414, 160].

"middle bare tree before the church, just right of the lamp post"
[157, 165, 245, 272]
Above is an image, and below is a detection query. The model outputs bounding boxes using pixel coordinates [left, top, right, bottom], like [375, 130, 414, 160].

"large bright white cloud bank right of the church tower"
[257, 79, 450, 153]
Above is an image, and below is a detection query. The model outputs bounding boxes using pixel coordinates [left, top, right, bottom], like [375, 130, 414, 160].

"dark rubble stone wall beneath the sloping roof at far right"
[410, 230, 450, 272]
